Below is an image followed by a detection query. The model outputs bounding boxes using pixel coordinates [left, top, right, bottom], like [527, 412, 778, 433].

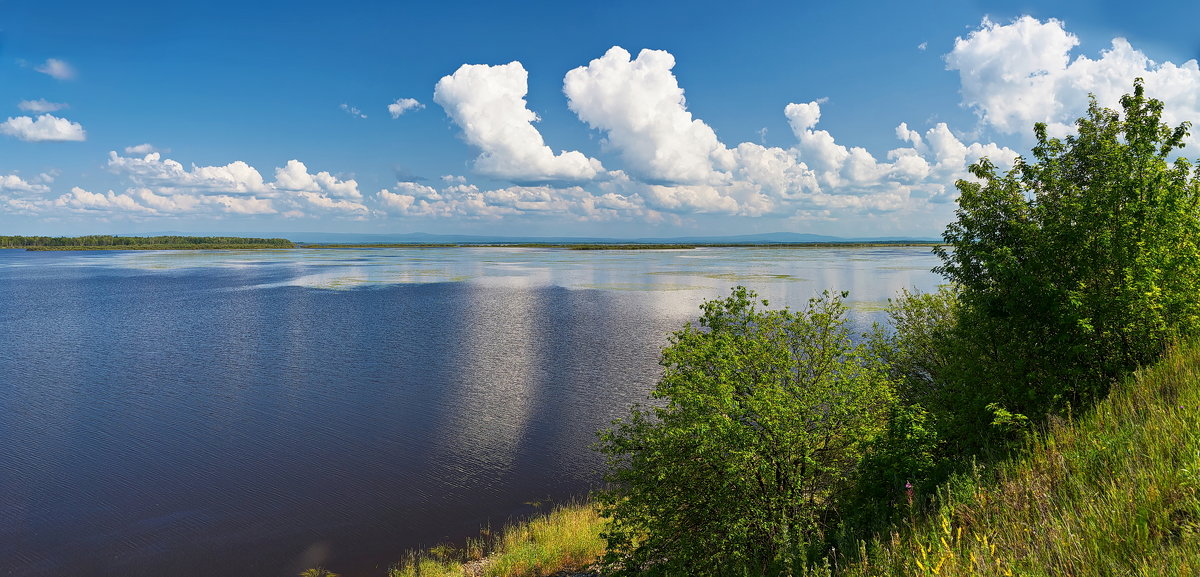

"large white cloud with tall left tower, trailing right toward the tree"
[563, 47, 1016, 218]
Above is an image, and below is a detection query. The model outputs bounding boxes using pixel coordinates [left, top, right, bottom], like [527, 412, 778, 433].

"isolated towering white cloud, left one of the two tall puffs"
[433, 61, 604, 182]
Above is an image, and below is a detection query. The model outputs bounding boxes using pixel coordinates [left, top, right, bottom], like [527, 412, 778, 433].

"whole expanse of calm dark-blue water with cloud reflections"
[0, 248, 938, 577]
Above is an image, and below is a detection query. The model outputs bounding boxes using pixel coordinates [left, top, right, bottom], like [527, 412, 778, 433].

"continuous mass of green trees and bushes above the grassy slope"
[599, 79, 1200, 576]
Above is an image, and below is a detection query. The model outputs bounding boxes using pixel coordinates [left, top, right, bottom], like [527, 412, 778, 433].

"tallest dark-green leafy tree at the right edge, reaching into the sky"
[936, 79, 1200, 424]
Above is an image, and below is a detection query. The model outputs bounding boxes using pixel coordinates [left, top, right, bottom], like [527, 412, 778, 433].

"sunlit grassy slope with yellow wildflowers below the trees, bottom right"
[836, 345, 1200, 577]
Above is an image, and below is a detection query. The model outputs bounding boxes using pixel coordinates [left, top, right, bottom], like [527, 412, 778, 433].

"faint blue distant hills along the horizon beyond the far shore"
[140, 233, 941, 245]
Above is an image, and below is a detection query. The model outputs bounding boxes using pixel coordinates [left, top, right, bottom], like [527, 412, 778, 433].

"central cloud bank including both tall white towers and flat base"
[398, 41, 1016, 226]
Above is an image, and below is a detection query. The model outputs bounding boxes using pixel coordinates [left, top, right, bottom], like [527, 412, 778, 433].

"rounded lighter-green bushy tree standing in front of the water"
[598, 287, 894, 576]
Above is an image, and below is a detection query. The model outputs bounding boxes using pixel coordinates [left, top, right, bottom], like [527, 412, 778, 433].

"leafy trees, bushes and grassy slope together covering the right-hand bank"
[300, 80, 1200, 577]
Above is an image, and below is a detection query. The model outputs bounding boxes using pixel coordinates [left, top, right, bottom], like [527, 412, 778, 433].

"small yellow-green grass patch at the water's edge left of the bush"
[388, 503, 604, 577]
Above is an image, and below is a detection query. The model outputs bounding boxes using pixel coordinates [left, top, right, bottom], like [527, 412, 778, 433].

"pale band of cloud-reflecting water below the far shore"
[23, 247, 937, 319]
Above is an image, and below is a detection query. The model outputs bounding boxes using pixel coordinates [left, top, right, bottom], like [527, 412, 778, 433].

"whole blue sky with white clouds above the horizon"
[0, 0, 1200, 236]
